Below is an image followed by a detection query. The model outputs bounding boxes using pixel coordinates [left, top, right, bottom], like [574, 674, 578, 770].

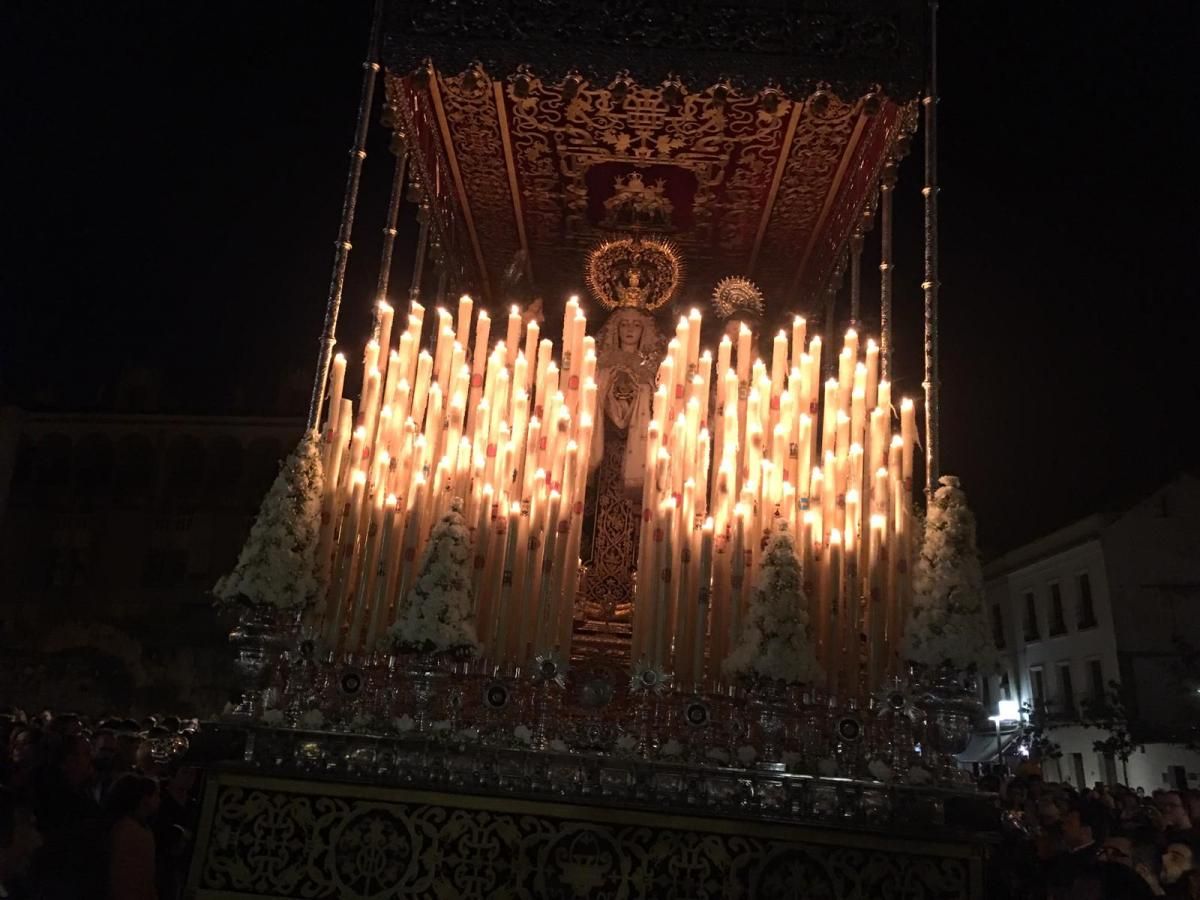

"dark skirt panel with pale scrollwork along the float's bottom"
[188, 773, 983, 900]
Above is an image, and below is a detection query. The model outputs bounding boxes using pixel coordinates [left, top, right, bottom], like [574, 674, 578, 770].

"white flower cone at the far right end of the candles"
[904, 475, 996, 670]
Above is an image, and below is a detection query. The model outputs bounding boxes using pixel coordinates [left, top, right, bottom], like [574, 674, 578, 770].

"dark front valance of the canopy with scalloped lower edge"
[383, 0, 925, 100]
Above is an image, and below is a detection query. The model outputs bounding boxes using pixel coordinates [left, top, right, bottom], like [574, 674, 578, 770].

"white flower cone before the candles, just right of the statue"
[724, 529, 821, 684]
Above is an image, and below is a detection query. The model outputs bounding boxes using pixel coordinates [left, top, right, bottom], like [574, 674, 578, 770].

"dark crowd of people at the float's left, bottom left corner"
[0, 710, 200, 900]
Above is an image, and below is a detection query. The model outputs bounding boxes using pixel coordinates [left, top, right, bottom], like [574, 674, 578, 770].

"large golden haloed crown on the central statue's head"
[587, 238, 683, 311]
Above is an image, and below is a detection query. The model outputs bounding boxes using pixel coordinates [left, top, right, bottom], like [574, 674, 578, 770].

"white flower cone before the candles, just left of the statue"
[389, 500, 479, 653]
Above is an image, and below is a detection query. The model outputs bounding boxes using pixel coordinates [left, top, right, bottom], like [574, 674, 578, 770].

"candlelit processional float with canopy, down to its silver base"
[192, 2, 993, 895]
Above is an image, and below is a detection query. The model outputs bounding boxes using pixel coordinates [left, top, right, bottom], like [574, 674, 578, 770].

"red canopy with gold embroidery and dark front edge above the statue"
[383, 0, 924, 306]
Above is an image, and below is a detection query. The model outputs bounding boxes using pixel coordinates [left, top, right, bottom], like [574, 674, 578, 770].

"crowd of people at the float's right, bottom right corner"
[980, 773, 1200, 900]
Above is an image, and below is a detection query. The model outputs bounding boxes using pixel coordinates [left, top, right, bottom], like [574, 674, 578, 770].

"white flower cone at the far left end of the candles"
[212, 431, 325, 611]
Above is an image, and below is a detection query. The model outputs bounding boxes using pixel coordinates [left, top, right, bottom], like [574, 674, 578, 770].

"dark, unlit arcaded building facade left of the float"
[0, 407, 304, 713]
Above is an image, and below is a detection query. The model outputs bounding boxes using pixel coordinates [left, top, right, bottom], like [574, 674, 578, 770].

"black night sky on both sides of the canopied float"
[0, 0, 1200, 552]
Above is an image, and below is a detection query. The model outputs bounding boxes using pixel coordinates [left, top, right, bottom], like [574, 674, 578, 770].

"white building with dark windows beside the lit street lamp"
[983, 475, 1200, 791]
